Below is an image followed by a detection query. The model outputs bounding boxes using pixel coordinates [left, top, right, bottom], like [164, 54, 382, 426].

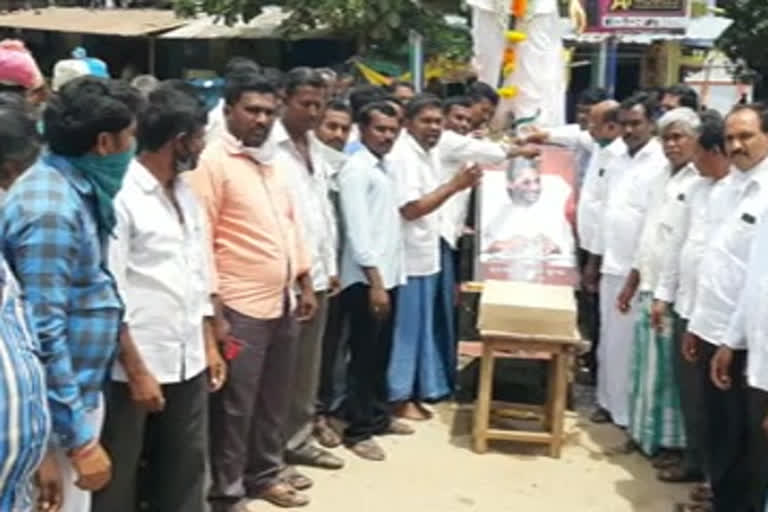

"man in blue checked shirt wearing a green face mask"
[0, 77, 140, 512]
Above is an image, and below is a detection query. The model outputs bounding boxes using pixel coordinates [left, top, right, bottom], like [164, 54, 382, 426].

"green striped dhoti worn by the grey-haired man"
[628, 292, 685, 455]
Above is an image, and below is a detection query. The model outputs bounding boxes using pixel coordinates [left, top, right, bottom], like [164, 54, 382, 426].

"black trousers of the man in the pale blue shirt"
[341, 284, 397, 445]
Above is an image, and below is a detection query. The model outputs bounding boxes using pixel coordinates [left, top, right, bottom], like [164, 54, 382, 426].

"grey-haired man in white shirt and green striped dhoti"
[618, 108, 700, 458]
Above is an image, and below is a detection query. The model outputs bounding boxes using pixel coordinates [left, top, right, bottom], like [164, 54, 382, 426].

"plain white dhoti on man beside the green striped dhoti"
[597, 274, 638, 427]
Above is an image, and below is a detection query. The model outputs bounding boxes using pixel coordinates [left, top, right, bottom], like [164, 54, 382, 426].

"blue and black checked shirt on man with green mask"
[0, 154, 122, 449]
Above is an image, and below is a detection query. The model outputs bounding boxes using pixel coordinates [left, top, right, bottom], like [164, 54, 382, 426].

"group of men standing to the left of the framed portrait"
[0, 43, 535, 512]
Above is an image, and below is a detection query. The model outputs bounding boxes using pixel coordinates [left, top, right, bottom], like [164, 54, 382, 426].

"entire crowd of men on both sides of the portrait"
[0, 38, 768, 512]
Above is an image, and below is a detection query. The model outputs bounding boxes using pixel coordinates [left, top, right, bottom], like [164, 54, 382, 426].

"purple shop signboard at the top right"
[583, 0, 690, 33]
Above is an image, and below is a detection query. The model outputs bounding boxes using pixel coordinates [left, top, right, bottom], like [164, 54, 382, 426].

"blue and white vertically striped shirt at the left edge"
[0, 258, 50, 510]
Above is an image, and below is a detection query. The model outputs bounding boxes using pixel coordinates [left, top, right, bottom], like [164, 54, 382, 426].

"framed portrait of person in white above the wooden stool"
[475, 146, 578, 286]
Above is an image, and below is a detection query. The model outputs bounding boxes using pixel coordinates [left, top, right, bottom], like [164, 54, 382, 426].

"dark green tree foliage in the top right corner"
[718, 0, 768, 91]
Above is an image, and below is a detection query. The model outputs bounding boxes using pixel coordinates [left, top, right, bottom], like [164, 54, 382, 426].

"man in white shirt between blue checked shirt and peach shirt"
[93, 85, 226, 512]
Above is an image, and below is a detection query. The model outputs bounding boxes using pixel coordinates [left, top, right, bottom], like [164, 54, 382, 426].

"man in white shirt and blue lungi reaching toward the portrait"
[389, 94, 481, 419]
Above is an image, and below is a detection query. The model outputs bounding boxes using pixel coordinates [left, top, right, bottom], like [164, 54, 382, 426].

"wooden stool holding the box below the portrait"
[472, 332, 581, 458]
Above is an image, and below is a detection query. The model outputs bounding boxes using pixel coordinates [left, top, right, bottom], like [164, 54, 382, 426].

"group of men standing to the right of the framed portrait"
[527, 85, 768, 512]
